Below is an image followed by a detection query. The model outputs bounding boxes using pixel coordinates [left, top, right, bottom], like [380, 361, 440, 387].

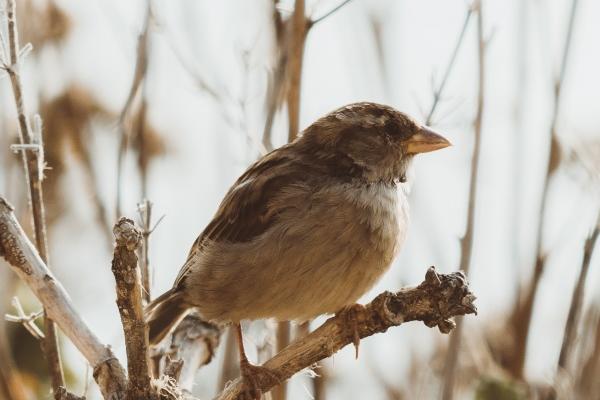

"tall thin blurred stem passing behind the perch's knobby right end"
[442, 0, 486, 400]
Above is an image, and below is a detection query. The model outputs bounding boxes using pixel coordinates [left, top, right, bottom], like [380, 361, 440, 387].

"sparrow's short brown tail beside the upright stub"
[144, 288, 189, 345]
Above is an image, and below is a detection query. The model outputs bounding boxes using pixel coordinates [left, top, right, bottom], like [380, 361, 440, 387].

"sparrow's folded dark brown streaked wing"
[175, 147, 310, 286]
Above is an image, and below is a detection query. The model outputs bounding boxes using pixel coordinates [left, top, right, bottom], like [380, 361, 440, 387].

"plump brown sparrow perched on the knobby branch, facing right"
[146, 102, 450, 396]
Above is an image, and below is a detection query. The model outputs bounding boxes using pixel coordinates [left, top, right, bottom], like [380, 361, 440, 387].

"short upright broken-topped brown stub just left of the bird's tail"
[112, 218, 156, 399]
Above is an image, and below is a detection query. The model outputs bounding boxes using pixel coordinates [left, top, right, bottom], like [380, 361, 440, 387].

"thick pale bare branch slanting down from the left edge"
[0, 197, 126, 399]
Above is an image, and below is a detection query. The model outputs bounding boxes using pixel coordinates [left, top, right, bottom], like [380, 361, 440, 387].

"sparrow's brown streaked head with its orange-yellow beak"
[298, 103, 450, 182]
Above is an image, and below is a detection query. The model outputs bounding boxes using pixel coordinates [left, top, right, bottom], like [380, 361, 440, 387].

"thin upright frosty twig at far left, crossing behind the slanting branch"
[2, 0, 65, 395]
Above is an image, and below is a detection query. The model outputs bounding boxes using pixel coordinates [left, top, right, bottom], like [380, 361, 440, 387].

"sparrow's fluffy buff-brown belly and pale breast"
[185, 181, 408, 322]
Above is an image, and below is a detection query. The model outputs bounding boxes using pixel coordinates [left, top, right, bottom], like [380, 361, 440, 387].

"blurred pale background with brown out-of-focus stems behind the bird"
[0, 0, 600, 400]
